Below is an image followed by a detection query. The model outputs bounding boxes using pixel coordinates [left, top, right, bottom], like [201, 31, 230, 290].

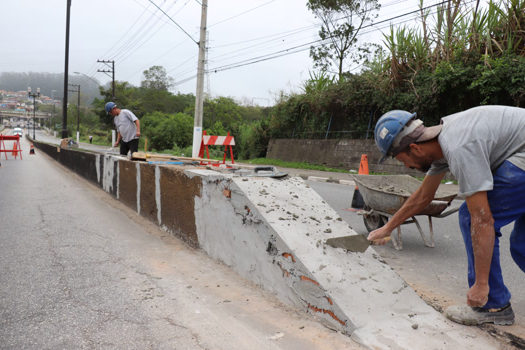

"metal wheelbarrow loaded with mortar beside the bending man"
[353, 175, 459, 250]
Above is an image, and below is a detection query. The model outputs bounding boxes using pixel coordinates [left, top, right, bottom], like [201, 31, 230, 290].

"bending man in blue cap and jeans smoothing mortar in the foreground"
[368, 106, 525, 325]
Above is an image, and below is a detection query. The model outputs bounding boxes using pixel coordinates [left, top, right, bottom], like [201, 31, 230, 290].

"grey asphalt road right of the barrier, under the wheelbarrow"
[307, 181, 525, 338]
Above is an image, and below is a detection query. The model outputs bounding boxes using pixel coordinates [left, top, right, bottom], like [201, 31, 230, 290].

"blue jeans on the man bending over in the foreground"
[459, 161, 525, 308]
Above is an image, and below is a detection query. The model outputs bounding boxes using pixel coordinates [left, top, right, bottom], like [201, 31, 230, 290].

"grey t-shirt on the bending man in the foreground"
[427, 106, 525, 197]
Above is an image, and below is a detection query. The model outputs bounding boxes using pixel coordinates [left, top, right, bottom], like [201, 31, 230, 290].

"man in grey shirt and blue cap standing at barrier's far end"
[105, 102, 140, 155]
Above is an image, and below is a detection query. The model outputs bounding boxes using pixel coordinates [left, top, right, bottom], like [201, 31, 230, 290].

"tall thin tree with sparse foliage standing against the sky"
[307, 0, 380, 81]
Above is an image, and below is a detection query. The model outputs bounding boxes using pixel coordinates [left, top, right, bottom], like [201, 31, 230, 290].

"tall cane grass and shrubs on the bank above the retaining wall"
[269, 0, 525, 138]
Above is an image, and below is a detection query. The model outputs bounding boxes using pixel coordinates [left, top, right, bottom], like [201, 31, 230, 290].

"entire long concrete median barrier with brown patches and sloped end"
[2, 128, 521, 349]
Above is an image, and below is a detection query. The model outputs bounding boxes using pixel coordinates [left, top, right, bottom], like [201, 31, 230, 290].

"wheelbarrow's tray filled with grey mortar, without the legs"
[353, 175, 457, 216]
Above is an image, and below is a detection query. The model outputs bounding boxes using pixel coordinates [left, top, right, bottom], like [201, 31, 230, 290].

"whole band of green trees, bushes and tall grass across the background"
[39, 0, 525, 172]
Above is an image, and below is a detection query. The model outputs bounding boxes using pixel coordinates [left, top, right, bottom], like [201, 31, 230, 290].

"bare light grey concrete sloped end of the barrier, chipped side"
[188, 171, 502, 349]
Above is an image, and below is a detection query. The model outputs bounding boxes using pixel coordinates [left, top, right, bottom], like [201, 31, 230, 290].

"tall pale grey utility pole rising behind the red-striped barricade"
[192, 0, 208, 158]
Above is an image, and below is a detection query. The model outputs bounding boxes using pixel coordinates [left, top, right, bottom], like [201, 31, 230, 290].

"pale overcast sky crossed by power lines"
[0, 0, 446, 105]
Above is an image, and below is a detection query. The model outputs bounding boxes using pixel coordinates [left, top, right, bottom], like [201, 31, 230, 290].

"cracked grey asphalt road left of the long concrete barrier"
[0, 135, 360, 350]
